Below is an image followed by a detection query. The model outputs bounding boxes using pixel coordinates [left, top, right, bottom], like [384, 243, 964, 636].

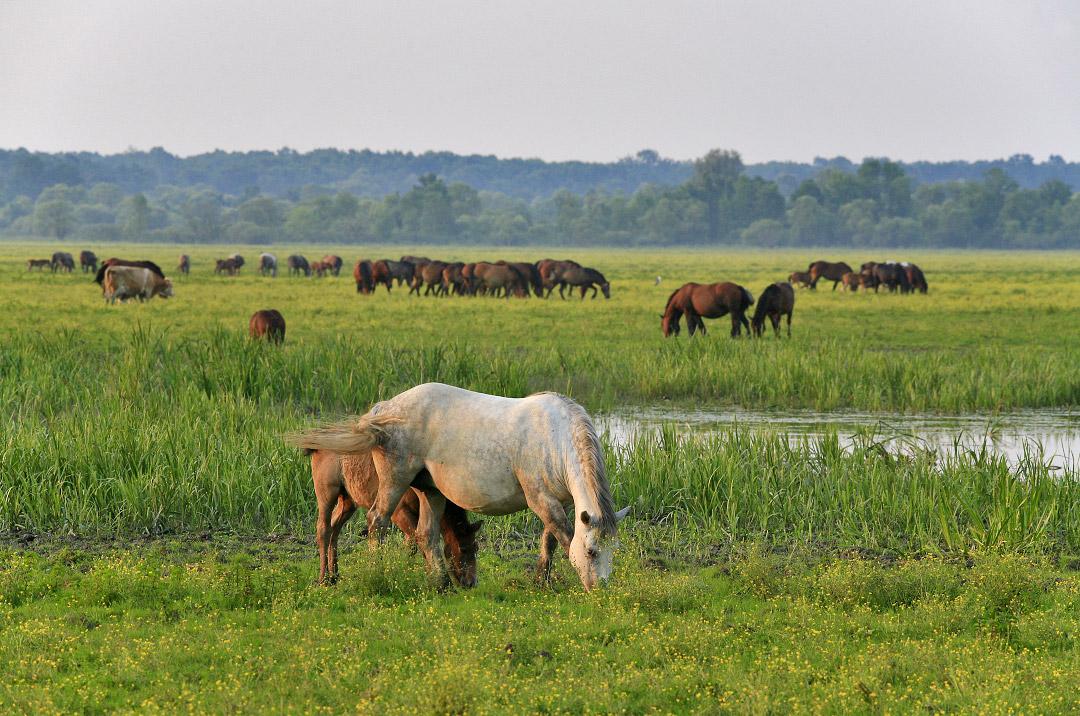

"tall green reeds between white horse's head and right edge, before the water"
[611, 425, 1080, 553]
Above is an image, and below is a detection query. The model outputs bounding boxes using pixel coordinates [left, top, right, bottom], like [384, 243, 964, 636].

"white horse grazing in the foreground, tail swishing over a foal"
[293, 383, 630, 590]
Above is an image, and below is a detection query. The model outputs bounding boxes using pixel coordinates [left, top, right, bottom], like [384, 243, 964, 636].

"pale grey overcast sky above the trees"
[0, 0, 1080, 162]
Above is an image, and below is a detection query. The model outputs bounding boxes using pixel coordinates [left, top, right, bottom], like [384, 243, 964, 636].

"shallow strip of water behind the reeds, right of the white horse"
[597, 407, 1080, 471]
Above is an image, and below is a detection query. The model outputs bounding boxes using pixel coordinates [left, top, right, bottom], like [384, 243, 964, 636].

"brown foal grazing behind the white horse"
[306, 450, 483, 587]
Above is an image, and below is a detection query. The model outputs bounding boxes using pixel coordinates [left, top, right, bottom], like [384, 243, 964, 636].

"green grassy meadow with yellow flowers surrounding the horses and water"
[0, 244, 1080, 713]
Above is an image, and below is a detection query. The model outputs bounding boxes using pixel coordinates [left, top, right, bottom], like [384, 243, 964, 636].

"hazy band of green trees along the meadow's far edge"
[0, 150, 1080, 248]
